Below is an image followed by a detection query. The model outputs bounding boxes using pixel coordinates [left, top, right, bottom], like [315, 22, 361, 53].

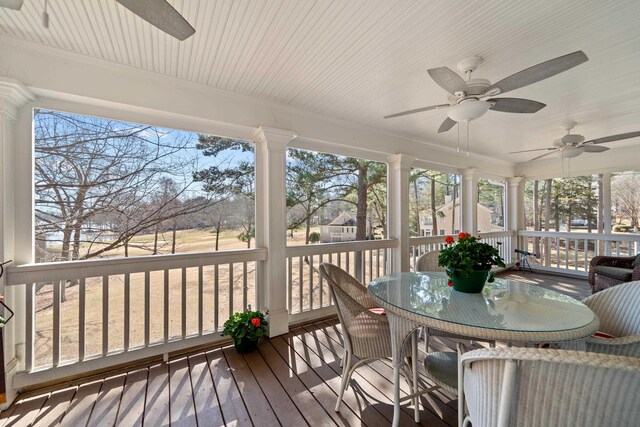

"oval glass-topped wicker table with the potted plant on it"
[368, 272, 599, 426]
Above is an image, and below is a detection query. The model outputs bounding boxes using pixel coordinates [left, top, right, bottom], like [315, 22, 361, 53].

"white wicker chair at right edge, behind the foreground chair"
[582, 281, 640, 357]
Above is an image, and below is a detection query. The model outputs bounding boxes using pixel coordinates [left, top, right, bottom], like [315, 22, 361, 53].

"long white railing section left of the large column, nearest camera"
[7, 249, 267, 387]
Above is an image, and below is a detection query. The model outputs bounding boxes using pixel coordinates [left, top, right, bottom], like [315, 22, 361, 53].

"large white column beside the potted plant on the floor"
[254, 127, 296, 337]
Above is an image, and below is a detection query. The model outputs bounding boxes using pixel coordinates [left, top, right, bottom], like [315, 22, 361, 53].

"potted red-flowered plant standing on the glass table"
[438, 232, 505, 293]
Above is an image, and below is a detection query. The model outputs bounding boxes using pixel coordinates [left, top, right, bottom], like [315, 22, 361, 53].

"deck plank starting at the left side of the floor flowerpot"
[223, 347, 280, 427]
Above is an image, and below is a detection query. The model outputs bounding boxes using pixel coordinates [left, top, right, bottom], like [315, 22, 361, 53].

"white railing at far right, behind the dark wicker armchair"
[518, 231, 640, 276]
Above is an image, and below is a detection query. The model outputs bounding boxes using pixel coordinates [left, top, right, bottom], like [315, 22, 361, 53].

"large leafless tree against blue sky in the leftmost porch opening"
[34, 110, 206, 260]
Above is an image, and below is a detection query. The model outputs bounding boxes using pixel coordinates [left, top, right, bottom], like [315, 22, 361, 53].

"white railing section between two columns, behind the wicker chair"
[287, 240, 398, 322]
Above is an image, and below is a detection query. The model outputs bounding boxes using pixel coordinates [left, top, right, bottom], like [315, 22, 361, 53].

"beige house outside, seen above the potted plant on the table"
[419, 199, 502, 236]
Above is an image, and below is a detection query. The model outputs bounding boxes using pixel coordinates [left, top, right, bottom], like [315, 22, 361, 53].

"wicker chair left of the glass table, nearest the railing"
[320, 263, 457, 412]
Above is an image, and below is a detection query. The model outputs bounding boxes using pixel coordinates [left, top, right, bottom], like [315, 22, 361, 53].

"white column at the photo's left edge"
[0, 77, 34, 409]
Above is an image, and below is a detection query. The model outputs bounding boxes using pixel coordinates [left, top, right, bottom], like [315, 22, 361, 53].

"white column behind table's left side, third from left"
[387, 154, 415, 273]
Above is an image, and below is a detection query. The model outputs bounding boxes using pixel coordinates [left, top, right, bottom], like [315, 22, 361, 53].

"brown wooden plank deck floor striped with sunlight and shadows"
[0, 273, 590, 427]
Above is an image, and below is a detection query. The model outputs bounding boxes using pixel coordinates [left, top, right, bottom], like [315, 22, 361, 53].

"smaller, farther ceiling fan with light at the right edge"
[509, 120, 640, 161]
